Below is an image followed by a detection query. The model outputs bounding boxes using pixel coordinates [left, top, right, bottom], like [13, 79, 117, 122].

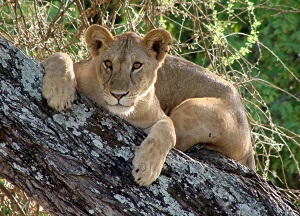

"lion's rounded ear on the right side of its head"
[142, 29, 172, 61]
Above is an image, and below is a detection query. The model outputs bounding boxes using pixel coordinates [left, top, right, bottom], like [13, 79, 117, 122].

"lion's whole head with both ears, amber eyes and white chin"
[85, 25, 172, 116]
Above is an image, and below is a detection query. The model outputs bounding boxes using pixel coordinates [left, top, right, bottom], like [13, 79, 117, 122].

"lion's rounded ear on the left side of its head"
[84, 25, 114, 57]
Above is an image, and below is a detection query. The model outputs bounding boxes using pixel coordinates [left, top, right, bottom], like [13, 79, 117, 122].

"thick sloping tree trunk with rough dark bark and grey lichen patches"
[0, 38, 299, 215]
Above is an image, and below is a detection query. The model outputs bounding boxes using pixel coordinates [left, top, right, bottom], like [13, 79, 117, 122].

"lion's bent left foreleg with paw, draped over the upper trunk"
[42, 53, 76, 111]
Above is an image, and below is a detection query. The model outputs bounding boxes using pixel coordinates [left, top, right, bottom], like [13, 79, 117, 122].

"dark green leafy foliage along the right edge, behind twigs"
[252, 0, 300, 189]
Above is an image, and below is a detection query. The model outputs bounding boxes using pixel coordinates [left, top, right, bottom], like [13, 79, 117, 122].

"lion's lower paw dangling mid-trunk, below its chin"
[132, 140, 166, 186]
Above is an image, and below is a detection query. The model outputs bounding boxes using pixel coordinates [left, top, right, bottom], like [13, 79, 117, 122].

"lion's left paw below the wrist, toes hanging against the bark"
[43, 75, 76, 111]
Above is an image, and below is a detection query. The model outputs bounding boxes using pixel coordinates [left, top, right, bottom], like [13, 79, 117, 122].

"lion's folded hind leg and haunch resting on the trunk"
[170, 98, 255, 169]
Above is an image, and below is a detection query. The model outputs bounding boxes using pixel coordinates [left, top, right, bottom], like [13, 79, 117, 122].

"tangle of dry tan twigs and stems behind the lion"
[0, 0, 300, 215]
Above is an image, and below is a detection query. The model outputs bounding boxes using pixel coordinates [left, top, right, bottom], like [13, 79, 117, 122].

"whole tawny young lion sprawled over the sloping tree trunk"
[42, 25, 255, 186]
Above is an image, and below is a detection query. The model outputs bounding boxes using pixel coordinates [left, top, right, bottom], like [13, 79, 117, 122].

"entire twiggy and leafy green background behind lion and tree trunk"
[0, 0, 300, 215]
